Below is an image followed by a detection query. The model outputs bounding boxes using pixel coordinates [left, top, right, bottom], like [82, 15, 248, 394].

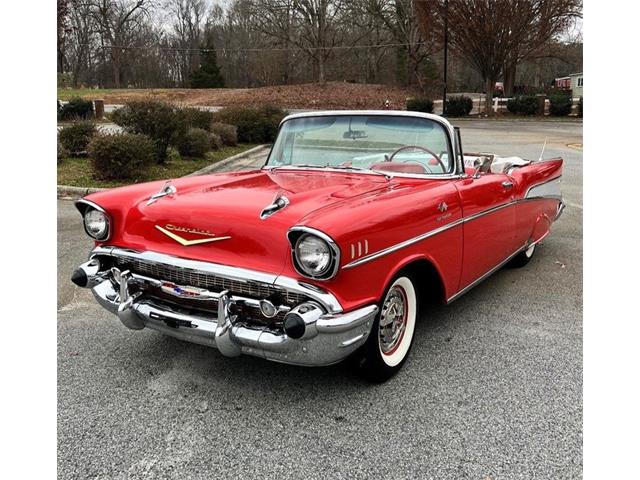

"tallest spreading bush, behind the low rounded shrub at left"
[111, 101, 182, 163]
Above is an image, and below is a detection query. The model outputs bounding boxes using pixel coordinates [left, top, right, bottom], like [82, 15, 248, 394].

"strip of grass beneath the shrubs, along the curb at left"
[58, 143, 256, 188]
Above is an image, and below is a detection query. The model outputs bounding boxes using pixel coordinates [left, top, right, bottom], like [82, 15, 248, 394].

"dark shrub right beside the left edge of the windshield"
[213, 106, 286, 143]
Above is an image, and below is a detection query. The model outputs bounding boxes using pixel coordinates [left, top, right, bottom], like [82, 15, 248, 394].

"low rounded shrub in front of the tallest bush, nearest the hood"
[89, 133, 155, 180]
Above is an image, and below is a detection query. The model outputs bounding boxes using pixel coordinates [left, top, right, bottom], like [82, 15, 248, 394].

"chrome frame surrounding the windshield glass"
[262, 110, 466, 180]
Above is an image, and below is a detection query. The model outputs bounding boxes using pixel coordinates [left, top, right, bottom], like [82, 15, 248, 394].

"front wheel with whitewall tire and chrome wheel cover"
[359, 275, 418, 383]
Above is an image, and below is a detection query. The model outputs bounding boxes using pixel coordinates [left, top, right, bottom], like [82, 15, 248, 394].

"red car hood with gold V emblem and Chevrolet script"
[88, 170, 387, 273]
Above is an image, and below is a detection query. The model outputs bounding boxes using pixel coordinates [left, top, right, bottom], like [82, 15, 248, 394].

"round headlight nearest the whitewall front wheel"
[290, 231, 340, 279]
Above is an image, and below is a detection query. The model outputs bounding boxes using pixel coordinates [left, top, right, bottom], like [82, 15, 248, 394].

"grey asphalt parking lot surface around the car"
[58, 120, 582, 480]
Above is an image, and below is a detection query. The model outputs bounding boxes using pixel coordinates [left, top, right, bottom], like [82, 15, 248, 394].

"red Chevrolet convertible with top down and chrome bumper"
[72, 111, 564, 381]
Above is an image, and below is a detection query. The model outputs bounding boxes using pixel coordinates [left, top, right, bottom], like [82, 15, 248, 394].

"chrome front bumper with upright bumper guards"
[74, 249, 378, 366]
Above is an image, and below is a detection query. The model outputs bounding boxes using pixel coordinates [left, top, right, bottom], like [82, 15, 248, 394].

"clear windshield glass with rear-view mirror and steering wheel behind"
[267, 115, 453, 174]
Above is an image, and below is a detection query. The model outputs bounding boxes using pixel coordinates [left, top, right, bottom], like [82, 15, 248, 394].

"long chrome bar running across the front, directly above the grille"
[89, 246, 343, 313]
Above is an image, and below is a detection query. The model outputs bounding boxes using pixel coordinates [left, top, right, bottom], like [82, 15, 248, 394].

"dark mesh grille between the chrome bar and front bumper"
[115, 257, 307, 305]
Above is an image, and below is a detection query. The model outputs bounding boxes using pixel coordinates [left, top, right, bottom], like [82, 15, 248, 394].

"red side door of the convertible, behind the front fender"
[456, 173, 517, 290]
